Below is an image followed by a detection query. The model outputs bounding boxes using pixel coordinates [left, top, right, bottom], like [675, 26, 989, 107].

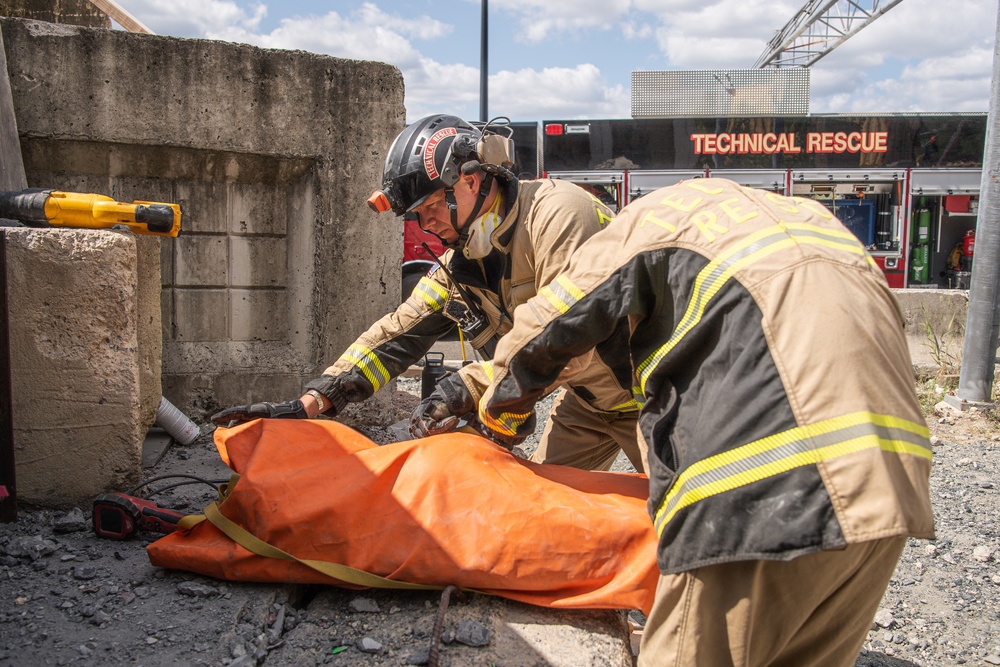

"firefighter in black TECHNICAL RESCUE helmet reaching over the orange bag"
[212, 114, 643, 471]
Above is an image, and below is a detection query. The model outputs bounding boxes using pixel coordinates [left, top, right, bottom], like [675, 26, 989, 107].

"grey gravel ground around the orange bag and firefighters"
[0, 380, 1000, 667]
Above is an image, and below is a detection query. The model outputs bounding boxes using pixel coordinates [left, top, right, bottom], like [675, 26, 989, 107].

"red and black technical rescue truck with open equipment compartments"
[537, 113, 986, 289]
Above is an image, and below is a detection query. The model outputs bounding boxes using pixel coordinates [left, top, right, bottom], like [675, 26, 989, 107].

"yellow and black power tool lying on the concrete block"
[0, 189, 181, 236]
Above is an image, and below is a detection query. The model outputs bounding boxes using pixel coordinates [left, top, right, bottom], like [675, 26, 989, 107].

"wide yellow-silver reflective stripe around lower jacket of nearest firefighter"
[653, 412, 932, 534]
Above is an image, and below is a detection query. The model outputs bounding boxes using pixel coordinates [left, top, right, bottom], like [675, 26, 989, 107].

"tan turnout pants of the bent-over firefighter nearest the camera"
[638, 537, 906, 667]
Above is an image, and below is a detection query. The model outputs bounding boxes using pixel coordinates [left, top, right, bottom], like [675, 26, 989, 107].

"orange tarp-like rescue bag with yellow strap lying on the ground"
[148, 419, 658, 613]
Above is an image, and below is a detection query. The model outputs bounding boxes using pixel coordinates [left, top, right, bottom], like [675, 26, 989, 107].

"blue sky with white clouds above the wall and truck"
[118, 0, 997, 121]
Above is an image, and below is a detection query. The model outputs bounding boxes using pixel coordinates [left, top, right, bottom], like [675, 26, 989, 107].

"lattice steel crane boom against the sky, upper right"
[754, 0, 902, 68]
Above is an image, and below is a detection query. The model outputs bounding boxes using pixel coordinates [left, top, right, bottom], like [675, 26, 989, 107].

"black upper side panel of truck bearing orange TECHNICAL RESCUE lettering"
[538, 113, 986, 172]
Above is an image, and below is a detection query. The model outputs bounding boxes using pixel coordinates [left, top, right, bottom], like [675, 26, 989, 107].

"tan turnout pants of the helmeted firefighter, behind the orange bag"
[531, 390, 648, 473]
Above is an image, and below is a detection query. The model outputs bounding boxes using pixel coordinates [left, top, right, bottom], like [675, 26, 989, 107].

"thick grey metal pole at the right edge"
[957, 2, 1000, 403]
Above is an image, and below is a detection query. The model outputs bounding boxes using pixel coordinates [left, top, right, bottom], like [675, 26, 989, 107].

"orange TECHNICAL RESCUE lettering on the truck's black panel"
[691, 132, 889, 155]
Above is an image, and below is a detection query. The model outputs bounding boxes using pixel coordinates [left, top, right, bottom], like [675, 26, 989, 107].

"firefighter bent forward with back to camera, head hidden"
[479, 179, 934, 667]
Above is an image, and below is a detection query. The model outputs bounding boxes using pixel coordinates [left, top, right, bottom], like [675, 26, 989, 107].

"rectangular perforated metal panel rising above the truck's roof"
[632, 68, 809, 118]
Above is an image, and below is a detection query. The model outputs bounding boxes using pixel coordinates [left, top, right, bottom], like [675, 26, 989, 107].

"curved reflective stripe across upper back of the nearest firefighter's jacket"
[636, 222, 873, 394]
